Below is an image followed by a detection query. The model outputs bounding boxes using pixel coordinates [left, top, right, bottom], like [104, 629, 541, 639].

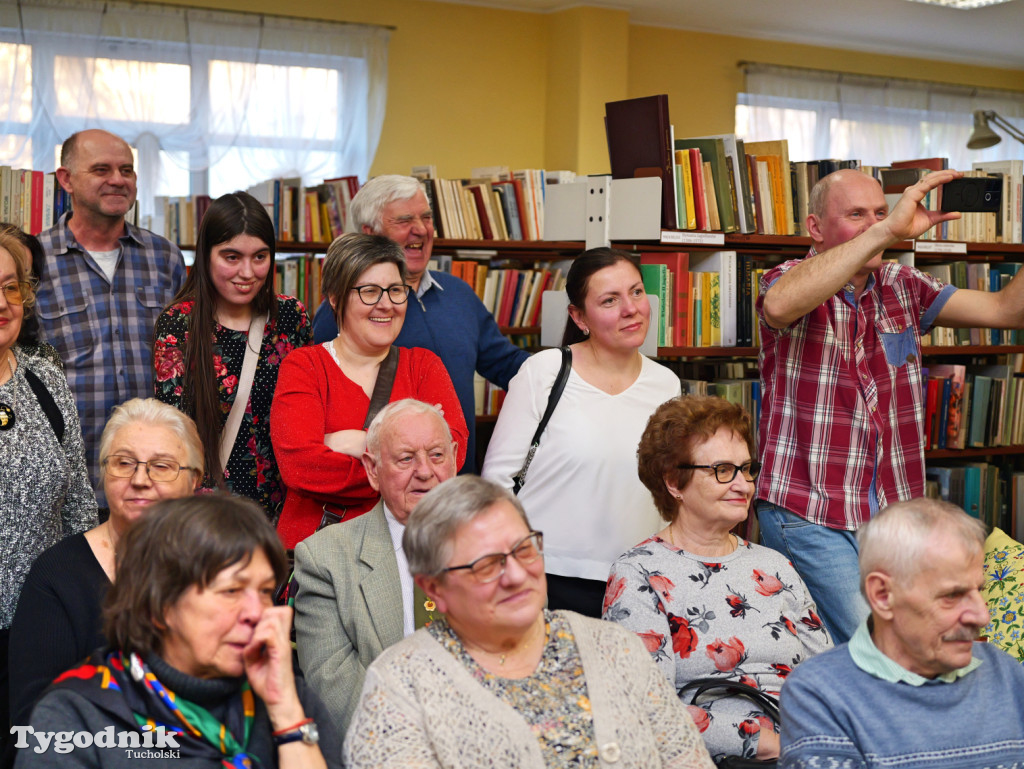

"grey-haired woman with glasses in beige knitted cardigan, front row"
[344, 475, 713, 769]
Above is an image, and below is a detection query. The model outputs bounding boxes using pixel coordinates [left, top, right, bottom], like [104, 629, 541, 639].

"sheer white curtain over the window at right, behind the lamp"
[736, 65, 1024, 169]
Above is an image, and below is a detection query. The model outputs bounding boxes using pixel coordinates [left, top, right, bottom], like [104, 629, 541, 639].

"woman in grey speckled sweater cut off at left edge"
[0, 225, 96, 760]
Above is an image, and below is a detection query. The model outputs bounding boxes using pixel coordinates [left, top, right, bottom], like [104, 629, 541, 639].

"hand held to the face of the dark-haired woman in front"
[243, 606, 303, 729]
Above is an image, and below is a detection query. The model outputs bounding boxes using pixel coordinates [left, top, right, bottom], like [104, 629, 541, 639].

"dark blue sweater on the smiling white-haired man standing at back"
[313, 271, 529, 473]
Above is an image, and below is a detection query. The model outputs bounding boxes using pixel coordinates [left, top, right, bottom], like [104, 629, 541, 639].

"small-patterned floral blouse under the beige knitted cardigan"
[427, 611, 600, 769]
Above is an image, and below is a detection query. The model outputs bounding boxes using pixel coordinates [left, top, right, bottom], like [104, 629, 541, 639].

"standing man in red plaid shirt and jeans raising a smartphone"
[757, 170, 1024, 644]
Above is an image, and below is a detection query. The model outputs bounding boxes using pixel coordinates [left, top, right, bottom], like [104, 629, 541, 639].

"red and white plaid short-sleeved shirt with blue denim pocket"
[757, 249, 956, 530]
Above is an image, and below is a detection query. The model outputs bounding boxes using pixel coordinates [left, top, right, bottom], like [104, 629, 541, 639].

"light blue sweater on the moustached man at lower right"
[779, 643, 1024, 769]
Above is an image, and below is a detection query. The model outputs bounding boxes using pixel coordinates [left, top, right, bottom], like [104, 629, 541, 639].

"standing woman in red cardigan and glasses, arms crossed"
[270, 233, 468, 548]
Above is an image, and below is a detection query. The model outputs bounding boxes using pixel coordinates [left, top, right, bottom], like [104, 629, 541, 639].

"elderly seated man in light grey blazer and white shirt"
[295, 398, 456, 733]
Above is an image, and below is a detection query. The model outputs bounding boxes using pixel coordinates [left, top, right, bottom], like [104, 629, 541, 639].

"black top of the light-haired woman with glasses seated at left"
[8, 533, 111, 724]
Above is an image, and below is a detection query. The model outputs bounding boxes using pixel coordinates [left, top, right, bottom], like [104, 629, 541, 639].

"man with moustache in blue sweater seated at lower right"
[779, 499, 1024, 769]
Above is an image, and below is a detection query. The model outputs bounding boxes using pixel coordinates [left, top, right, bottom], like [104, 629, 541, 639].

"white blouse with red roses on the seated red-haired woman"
[603, 537, 833, 759]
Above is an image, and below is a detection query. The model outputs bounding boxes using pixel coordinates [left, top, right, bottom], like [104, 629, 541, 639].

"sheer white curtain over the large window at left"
[0, 0, 390, 216]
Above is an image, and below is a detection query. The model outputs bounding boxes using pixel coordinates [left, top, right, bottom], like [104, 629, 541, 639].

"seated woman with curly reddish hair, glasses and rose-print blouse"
[603, 396, 833, 761]
